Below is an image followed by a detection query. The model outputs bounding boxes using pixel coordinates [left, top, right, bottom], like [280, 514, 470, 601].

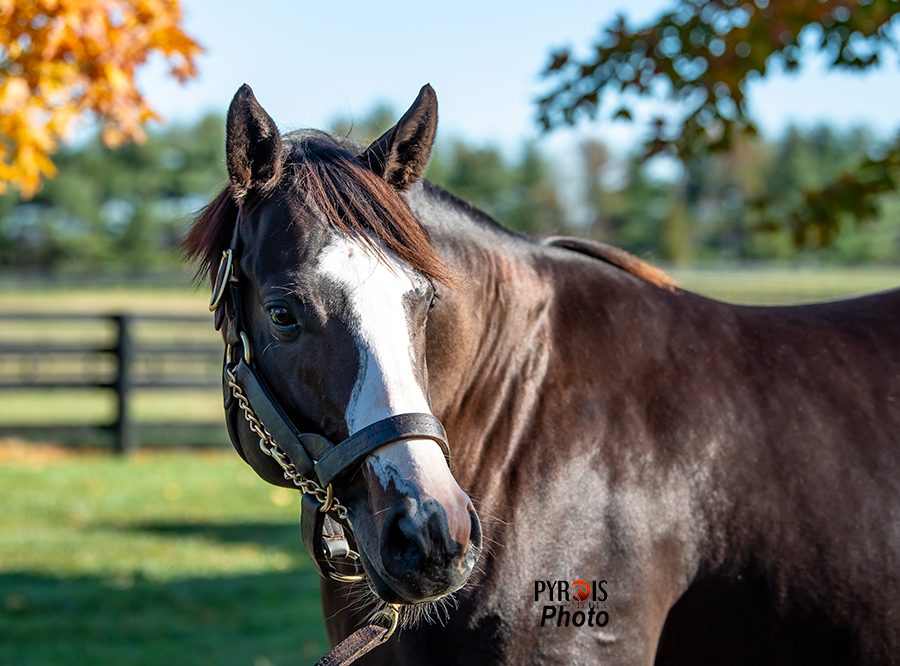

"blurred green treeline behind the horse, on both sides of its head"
[0, 108, 900, 272]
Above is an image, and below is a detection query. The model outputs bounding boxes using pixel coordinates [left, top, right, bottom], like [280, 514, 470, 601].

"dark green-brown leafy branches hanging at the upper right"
[539, 0, 900, 246]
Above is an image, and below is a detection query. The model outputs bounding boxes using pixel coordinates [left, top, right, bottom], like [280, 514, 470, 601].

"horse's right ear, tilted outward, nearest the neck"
[359, 84, 437, 192]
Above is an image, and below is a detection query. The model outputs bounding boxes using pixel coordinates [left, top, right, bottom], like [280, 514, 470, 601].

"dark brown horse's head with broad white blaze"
[187, 86, 481, 604]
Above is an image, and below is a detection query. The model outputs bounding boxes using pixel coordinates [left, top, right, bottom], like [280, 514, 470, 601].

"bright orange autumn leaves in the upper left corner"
[0, 0, 201, 197]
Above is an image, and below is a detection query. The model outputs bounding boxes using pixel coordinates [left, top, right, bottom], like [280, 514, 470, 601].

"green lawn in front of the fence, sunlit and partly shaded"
[0, 444, 326, 666]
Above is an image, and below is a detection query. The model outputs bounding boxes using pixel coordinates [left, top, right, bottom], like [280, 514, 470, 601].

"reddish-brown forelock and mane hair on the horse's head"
[182, 132, 456, 284]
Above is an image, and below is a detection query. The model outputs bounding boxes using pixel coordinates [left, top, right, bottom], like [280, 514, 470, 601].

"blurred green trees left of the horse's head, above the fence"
[0, 115, 227, 271]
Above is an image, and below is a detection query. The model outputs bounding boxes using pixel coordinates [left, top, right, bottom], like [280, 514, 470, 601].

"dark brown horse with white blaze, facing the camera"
[186, 85, 900, 666]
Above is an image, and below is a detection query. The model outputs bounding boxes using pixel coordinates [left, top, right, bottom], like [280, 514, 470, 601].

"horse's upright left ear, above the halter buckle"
[225, 83, 281, 201]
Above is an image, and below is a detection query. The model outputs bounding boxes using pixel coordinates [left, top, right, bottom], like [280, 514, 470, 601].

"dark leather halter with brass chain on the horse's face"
[209, 214, 450, 581]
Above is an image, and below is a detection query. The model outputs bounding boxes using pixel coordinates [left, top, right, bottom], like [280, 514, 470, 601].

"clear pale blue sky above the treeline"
[140, 0, 900, 150]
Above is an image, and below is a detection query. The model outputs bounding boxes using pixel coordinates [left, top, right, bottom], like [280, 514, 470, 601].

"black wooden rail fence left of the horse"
[0, 313, 224, 453]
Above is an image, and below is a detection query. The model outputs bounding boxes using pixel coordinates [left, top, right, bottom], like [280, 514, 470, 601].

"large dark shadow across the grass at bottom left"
[0, 570, 327, 666]
